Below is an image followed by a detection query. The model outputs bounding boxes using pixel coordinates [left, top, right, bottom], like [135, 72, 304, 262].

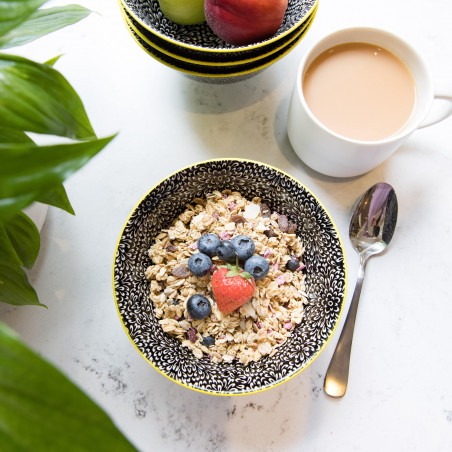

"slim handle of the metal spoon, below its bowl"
[323, 257, 366, 397]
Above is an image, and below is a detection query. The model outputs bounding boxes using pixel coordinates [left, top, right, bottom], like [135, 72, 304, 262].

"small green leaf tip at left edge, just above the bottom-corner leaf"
[0, 261, 40, 306]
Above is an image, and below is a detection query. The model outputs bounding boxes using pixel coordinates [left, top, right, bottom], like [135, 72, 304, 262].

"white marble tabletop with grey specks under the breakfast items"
[0, 0, 452, 452]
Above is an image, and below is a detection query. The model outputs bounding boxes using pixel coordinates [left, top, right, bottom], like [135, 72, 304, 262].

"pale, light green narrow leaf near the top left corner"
[0, 5, 91, 49]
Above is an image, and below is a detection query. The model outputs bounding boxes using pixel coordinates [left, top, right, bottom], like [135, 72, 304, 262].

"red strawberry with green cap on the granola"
[212, 263, 256, 314]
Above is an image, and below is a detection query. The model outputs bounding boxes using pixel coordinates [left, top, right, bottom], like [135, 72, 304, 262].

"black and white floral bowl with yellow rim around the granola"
[113, 159, 346, 396]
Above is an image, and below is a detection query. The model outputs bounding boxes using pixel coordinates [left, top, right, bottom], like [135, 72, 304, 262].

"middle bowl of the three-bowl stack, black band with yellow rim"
[121, 4, 317, 66]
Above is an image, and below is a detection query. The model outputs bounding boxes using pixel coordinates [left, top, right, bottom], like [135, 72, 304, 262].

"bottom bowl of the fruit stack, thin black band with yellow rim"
[121, 12, 313, 79]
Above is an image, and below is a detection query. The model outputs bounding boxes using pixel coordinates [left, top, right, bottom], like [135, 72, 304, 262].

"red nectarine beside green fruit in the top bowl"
[204, 0, 288, 45]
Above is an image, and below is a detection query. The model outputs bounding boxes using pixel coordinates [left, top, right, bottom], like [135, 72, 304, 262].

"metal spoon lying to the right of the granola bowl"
[324, 182, 397, 397]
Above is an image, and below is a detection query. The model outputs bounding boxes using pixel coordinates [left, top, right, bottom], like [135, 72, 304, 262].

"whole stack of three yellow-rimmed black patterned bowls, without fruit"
[119, 0, 318, 79]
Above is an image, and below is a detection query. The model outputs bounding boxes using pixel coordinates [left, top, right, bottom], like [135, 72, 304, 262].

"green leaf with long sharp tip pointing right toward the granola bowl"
[0, 136, 114, 219]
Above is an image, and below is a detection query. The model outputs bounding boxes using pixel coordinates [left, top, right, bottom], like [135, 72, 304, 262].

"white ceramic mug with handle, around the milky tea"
[287, 28, 452, 177]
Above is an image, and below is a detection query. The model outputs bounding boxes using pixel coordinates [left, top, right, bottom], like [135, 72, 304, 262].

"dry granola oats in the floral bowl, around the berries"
[146, 191, 307, 365]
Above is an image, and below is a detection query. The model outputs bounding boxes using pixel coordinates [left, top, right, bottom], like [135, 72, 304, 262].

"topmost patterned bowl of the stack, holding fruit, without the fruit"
[119, 0, 319, 63]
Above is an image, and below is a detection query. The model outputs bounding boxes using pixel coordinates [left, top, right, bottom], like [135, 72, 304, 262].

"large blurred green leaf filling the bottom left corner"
[0, 322, 136, 452]
